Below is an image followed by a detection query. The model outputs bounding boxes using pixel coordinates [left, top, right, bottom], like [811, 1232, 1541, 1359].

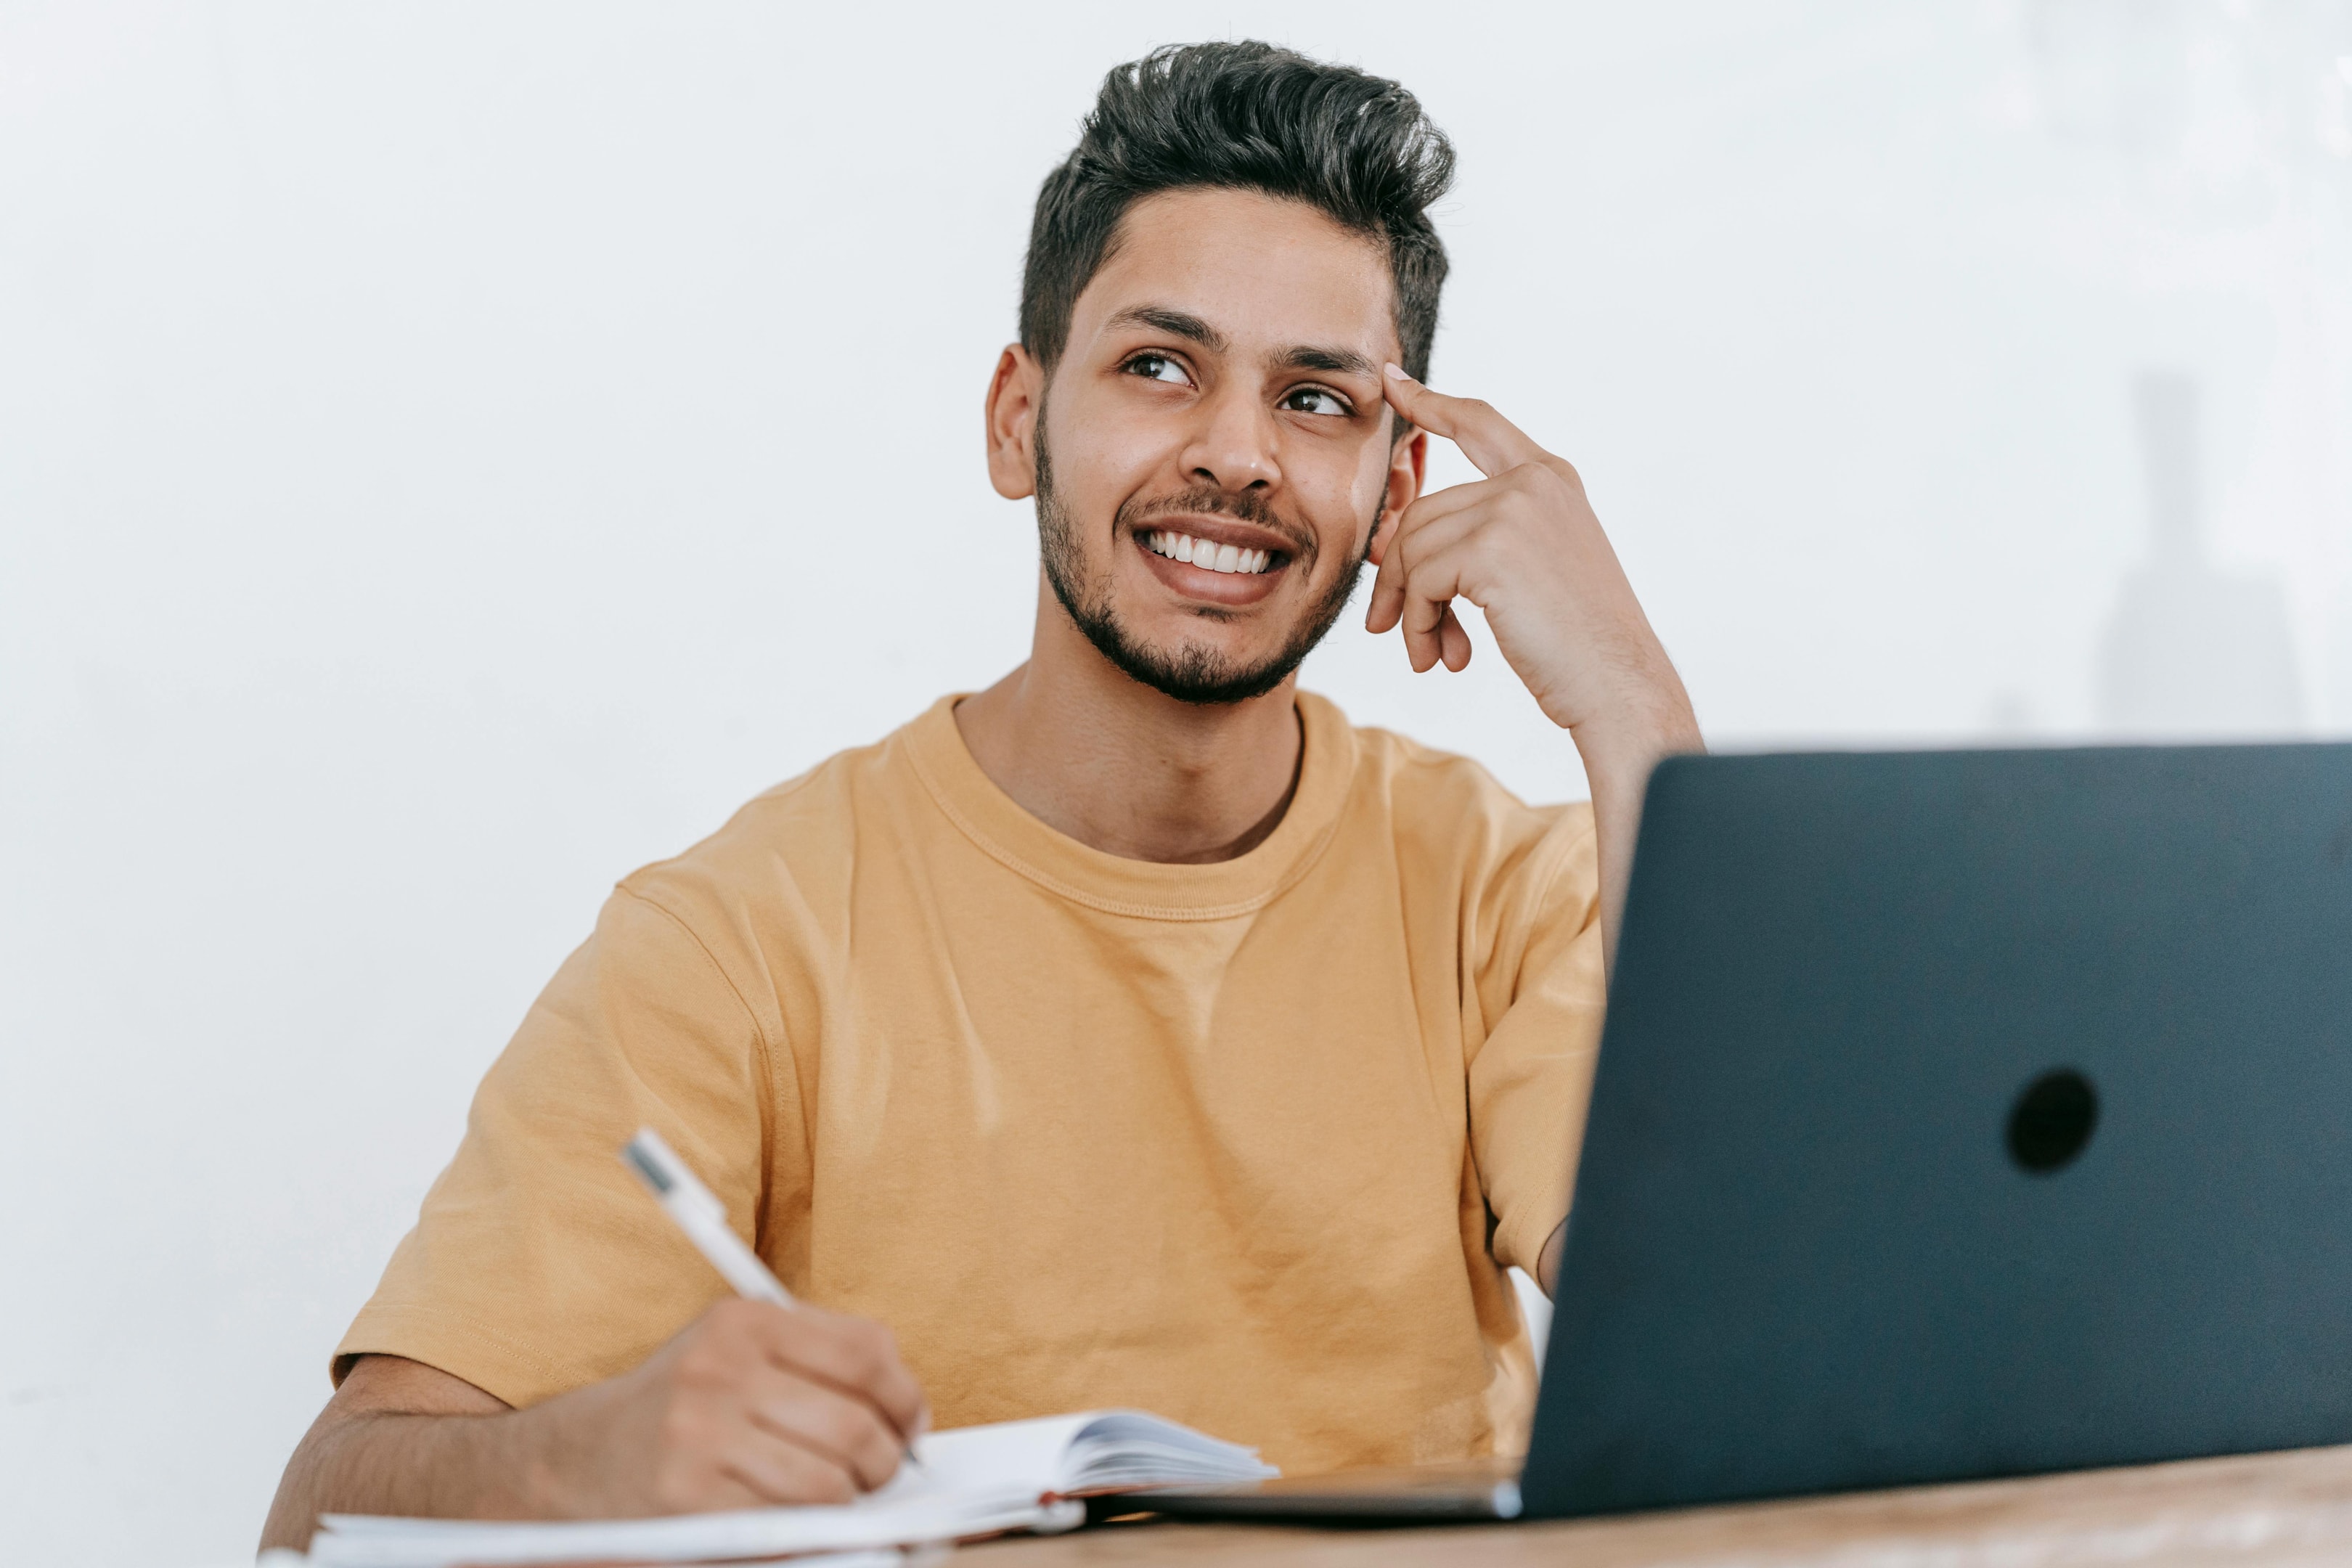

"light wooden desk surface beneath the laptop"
[957, 1448, 2352, 1568]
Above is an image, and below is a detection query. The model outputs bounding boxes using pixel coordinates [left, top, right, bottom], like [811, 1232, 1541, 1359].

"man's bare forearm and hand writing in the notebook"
[261, 1300, 929, 1551]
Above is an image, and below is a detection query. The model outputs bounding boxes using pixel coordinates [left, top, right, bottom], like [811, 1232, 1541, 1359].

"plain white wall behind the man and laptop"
[14, 0, 2352, 1566]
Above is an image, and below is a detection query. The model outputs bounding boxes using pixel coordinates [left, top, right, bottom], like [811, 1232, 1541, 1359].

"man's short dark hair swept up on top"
[1021, 42, 1453, 381]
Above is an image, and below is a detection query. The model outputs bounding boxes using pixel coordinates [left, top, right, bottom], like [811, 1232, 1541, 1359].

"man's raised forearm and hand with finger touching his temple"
[1364, 364, 1705, 964]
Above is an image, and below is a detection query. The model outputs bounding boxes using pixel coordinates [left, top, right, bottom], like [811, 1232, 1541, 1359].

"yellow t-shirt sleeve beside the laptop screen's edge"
[1470, 807, 1606, 1274]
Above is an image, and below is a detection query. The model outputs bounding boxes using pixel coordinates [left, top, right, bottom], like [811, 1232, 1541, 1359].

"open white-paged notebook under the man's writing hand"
[311, 1410, 1277, 1568]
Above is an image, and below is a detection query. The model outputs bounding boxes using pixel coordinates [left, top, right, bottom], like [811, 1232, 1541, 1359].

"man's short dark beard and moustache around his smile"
[1037, 422, 1371, 708]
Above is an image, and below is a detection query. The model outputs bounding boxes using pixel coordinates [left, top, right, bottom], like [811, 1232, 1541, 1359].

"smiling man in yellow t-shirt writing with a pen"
[266, 45, 1698, 1545]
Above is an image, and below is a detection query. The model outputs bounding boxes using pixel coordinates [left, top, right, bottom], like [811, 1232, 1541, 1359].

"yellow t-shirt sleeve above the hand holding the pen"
[334, 886, 804, 1406]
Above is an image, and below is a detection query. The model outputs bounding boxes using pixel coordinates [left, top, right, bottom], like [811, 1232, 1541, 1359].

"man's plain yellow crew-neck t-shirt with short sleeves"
[336, 696, 1601, 1474]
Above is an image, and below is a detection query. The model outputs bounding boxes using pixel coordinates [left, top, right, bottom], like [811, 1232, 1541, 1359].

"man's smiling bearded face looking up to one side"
[1000, 190, 1421, 703]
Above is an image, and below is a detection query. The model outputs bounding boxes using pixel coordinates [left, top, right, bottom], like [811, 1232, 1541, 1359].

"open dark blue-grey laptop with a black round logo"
[1148, 746, 2352, 1521]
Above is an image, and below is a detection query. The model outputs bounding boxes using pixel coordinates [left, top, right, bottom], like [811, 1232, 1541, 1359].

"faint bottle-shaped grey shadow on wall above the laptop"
[2098, 372, 2303, 740]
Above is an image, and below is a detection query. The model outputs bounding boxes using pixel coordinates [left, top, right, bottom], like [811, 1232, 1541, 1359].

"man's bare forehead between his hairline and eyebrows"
[1072, 190, 1397, 364]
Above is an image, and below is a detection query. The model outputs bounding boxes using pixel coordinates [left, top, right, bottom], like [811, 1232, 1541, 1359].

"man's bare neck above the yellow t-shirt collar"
[955, 592, 1303, 865]
